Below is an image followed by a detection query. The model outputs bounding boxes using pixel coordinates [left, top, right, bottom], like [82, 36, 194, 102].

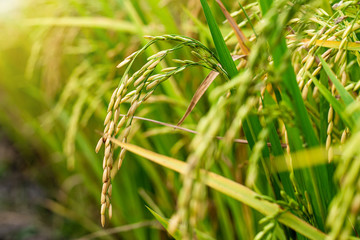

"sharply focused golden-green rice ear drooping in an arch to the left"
[95, 35, 250, 225]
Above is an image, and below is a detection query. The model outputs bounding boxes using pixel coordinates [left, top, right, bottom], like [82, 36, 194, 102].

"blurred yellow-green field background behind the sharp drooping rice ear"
[0, 0, 225, 239]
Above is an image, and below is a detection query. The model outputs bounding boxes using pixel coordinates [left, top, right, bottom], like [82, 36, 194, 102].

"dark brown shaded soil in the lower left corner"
[0, 132, 56, 240]
